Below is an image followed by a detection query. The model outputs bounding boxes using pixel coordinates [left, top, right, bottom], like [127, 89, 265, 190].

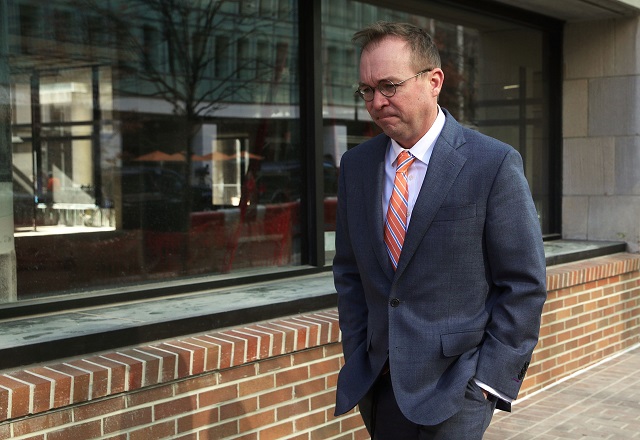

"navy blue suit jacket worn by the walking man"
[333, 110, 546, 425]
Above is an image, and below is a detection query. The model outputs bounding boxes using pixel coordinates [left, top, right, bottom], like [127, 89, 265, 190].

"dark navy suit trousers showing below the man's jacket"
[359, 373, 497, 440]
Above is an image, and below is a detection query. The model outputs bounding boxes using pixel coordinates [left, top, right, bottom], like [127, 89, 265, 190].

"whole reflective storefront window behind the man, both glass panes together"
[0, 0, 559, 300]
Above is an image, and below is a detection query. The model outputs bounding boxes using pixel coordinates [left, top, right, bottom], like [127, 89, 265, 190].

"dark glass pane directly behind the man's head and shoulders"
[322, 0, 553, 259]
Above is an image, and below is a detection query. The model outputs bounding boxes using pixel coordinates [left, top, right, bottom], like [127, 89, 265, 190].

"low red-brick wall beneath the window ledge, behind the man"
[0, 253, 640, 440]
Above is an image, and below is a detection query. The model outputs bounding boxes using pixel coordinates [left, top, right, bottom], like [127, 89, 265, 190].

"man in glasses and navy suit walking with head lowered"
[333, 22, 546, 440]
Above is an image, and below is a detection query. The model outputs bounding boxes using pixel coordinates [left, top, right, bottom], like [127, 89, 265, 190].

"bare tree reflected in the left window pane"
[78, 0, 282, 272]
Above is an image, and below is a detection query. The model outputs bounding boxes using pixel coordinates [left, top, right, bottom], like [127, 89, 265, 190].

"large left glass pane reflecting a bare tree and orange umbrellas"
[6, 0, 304, 299]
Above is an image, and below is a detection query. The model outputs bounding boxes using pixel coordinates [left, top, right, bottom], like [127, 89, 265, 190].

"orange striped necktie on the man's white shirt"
[384, 150, 415, 269]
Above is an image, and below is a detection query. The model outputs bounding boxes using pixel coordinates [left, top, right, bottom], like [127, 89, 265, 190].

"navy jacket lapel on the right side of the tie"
[395, 110, 467, 278]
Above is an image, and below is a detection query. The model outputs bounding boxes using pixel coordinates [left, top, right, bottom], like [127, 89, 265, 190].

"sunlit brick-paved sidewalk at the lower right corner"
[484, 345, 640, 440]
